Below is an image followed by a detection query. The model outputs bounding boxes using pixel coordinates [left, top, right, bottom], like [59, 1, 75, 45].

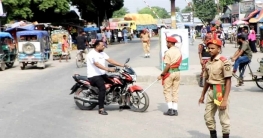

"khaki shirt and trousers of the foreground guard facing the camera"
[204, 55, 232, 134]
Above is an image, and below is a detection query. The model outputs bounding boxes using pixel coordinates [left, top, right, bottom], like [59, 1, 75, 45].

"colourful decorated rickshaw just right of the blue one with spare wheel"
[51, 30, 72, 60]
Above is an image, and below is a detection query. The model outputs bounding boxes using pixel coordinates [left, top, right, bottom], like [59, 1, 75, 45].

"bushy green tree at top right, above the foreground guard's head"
[193, 0, 217, 23]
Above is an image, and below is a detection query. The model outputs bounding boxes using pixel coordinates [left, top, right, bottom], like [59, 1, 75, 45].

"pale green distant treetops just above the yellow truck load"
[138, 6, 170, 18]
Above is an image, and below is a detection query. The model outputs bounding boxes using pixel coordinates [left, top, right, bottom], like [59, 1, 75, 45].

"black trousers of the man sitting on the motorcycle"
[89, 75, 108, 109]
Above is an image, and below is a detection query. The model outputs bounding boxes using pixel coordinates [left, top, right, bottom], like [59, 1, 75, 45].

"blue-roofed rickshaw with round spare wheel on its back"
[16, 30, 50, 70]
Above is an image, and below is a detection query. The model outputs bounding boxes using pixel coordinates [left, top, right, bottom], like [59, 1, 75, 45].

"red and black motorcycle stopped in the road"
[70, 58, 149, 112]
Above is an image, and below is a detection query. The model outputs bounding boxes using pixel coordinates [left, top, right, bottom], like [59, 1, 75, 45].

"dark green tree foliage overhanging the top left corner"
[2, 0, 69, 20]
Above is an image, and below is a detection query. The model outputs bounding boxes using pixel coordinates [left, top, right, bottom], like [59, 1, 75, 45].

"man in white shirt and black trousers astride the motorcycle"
[87, 40, 127, 115]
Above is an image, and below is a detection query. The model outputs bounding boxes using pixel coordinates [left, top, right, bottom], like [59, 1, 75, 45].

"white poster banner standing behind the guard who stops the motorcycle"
[159, 28, 189, 71]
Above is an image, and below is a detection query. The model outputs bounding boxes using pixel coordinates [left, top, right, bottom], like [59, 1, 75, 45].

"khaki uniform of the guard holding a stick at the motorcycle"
[163, 46, 182, 103]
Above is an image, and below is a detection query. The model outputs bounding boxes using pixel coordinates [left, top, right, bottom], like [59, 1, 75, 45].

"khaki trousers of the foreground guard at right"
[204, 90, 230, 134]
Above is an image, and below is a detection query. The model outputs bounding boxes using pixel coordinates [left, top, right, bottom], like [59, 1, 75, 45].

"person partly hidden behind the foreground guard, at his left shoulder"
[198, 35, 211, 87]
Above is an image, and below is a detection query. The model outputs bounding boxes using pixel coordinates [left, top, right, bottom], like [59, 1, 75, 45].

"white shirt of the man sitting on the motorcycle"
[86, 49, 109, 78]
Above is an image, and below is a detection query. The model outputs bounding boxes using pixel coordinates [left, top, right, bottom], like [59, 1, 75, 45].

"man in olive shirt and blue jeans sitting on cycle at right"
[231, 35, 252, 79]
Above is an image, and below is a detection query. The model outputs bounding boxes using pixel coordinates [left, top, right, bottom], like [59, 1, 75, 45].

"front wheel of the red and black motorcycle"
[130, 91, 150, 112]
